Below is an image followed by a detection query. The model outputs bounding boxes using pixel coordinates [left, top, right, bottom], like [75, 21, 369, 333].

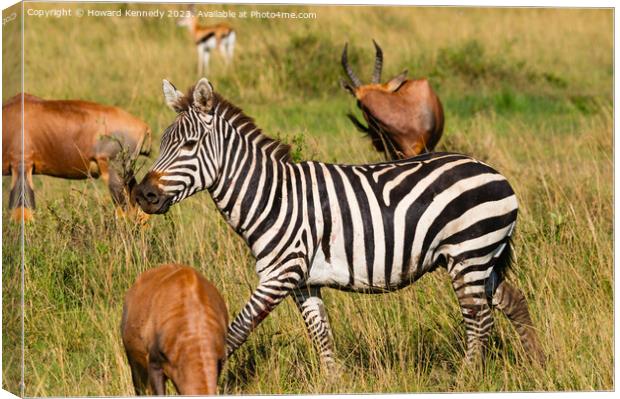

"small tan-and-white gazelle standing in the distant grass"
[177, 5, 237, 76]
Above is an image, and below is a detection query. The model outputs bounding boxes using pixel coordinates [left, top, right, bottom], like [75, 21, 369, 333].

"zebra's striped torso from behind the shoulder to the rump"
[297, 153, 517, 291]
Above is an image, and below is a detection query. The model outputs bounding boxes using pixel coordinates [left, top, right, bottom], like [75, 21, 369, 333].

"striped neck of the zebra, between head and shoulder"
[209, 104, 293, 254]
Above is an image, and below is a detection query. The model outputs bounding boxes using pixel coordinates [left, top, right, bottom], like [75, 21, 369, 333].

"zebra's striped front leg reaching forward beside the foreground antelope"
[226, 264, 305, 357]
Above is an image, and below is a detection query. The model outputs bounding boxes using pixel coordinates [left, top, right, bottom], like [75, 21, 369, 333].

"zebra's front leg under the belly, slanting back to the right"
[294, 287, 335, 368]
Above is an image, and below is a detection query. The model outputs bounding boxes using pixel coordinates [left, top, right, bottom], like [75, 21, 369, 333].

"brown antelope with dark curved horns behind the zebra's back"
[340, 40, 444, 159]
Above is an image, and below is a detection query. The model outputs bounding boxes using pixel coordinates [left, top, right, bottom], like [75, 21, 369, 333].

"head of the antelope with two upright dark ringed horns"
[340, 40, 407, 101]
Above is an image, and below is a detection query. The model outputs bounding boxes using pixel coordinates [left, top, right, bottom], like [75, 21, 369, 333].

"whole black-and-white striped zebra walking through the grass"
[132, 78, 544, 369]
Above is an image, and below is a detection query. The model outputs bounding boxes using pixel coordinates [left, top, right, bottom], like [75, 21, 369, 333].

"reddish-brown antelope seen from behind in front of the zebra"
[121, 265, 228, 395]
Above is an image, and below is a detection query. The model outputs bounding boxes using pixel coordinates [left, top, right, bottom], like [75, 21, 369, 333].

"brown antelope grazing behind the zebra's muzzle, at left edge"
[2, 93, 151, 221]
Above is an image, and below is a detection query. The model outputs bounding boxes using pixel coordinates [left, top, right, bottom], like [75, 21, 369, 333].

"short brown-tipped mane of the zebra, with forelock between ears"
[179, 86, 291, 161]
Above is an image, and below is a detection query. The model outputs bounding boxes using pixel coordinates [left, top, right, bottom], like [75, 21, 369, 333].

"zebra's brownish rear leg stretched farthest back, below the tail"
[493, 280, 546, 366]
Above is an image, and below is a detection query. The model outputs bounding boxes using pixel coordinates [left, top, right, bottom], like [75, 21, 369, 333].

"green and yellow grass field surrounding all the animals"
[2, 4, 614, 396]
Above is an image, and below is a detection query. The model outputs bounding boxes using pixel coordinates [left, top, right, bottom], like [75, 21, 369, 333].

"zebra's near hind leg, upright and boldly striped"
[450, 262, 493, 363]
